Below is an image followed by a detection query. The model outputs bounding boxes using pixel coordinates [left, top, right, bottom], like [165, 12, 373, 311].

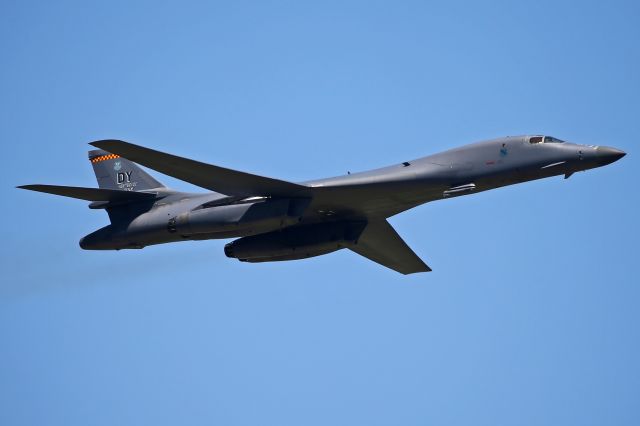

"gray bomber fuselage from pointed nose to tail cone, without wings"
[80, 136, 624, 250]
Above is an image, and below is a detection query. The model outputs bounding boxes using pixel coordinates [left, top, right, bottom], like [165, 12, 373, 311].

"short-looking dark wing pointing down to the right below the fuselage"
[349, 219, 431, 275]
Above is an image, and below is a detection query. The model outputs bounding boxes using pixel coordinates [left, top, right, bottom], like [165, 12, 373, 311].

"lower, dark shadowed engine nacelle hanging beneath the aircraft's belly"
[224, 221, 366, 262]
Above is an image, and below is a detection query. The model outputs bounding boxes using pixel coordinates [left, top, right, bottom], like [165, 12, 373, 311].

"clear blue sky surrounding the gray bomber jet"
[0, 0, 640, 426]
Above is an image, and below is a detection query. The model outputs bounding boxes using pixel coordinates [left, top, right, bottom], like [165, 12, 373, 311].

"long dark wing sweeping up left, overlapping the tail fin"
[91, 140, 310, 197]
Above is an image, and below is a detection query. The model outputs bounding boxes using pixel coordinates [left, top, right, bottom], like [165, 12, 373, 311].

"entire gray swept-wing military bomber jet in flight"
[18, 135, 625, 274]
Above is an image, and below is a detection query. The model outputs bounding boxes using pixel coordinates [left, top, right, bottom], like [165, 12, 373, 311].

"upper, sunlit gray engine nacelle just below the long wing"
[167, 199, 308, 237]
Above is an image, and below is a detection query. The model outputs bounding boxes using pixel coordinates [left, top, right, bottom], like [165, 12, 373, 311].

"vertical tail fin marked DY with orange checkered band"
[89, 149, 165, 191]
